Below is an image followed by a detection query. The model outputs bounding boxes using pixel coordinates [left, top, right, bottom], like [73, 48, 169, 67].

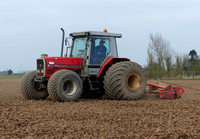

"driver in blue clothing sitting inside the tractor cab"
[95, 40, 106, 64]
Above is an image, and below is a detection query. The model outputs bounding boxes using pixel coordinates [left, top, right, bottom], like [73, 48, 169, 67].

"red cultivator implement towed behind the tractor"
[147, 82, 184, 99]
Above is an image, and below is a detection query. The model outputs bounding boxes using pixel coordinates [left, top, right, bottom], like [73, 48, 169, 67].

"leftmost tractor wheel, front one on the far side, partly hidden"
[20, 71, 49, 100]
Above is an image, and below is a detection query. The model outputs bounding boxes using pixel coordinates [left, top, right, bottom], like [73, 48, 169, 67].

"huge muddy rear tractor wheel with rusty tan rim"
[104, 61, 146, 100]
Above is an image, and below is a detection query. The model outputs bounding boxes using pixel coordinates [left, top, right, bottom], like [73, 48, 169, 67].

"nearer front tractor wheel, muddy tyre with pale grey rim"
[47, 70, 83, 102]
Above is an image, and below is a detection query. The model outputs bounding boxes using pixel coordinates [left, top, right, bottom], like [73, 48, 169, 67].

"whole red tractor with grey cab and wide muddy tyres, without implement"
[20, 29, 146, 102]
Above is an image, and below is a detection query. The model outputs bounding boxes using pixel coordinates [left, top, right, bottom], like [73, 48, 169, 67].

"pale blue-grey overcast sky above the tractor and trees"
[0, 0, 200, 72]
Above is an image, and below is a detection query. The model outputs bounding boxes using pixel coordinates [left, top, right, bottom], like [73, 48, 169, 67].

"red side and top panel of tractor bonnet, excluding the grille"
[45, 57, 83, 77]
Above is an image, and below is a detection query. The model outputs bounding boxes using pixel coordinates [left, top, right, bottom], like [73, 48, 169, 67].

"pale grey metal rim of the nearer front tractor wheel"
[63, 80, 78, 96]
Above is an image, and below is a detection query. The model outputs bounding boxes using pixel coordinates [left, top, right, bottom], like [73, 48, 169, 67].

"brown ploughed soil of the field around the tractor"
[0, 76, 200, 138]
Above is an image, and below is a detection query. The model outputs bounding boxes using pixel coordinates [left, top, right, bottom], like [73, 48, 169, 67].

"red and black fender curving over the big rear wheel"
[97, 57, 130, 77]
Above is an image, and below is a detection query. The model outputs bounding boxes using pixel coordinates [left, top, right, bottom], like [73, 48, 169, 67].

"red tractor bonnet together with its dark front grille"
[36, 57, 83, 78]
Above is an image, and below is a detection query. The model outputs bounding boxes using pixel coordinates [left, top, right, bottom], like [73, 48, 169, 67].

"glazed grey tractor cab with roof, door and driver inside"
[69, 31, 122, 76]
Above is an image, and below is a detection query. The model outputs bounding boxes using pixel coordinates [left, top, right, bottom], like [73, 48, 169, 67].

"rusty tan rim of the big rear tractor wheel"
[126, 73, 140, 92]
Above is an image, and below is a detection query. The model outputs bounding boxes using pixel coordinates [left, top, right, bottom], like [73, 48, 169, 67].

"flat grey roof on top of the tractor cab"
[69, 31, 122, 38]
